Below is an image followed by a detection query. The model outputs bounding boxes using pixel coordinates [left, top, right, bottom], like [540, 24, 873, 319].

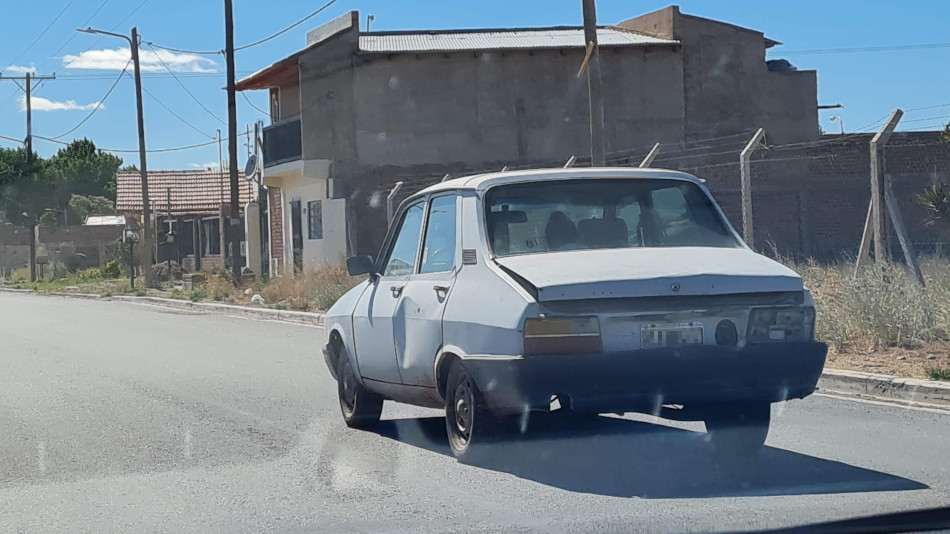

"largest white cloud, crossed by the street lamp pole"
[63, 48, 218, 72]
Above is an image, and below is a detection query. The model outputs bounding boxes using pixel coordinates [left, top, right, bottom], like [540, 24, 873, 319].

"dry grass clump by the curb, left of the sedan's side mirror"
[260, 265, 364, 311]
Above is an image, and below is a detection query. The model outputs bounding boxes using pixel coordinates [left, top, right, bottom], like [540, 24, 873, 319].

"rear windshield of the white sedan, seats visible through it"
[486, 178, 739, 256]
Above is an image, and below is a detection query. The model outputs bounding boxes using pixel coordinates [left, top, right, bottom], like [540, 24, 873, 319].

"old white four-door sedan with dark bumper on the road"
[324, 168, 827, 460]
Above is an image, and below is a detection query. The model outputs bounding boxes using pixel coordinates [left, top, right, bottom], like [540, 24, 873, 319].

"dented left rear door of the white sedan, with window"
[393, 193, 460, 387]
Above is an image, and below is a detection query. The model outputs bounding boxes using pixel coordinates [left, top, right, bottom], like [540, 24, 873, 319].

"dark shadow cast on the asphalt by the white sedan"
[376, 414, 927, 499]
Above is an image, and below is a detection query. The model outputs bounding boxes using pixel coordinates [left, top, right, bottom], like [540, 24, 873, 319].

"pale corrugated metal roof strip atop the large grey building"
[360, 27, 679, 53]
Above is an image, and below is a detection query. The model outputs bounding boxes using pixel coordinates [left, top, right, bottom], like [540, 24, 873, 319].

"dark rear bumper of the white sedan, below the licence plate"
[465, 342, 828, 414]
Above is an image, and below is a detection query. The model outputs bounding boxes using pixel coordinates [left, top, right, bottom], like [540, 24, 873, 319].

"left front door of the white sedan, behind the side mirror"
[353, 200, 424, 384]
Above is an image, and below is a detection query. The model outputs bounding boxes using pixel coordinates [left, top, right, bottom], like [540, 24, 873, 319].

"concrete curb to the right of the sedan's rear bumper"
[818, 369, 950, 408]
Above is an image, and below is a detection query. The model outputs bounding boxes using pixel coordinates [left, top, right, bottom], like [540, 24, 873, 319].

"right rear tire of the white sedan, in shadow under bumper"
[706, 402, 772, 457]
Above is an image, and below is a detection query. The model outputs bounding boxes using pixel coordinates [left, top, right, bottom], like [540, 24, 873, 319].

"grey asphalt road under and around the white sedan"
[0, 293, 950, 532]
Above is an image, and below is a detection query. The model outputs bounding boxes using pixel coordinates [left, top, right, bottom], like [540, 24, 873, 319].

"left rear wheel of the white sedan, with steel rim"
[445, 361, 496, 464]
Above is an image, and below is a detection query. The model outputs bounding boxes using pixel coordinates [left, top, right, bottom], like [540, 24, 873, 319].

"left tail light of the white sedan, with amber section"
[524, 317, 604, 354]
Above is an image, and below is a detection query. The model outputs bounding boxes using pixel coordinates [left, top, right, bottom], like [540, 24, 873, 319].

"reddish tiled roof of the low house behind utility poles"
[115, 171, 254, 213]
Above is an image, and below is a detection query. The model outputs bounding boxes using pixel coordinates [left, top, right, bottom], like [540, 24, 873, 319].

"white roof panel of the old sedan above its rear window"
[413, 167, 702, 196]
